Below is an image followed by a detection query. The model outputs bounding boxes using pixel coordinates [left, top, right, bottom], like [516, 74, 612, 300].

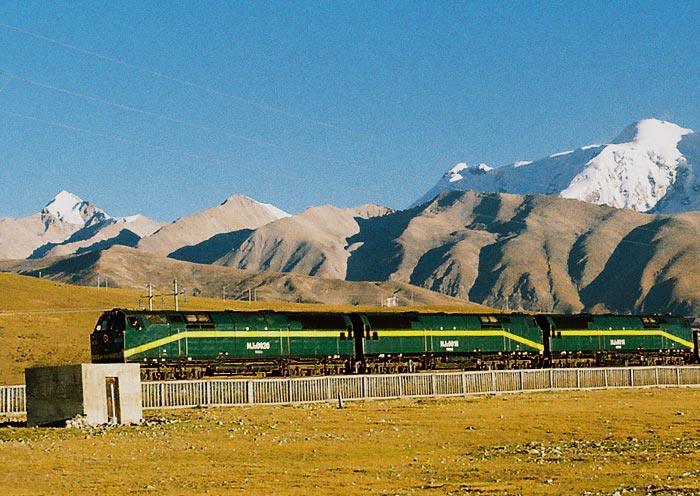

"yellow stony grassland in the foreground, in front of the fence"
[0, 388, 700, 496]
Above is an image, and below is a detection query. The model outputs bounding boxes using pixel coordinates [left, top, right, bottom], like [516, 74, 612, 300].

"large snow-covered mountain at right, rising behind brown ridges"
[414, 119, 700, 213]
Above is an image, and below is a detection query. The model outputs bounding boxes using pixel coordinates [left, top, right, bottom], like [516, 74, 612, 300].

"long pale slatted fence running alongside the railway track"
[0, 367, 700, 415]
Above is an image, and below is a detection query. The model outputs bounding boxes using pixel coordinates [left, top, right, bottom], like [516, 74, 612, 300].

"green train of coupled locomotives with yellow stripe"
[90, 309, 699, 380]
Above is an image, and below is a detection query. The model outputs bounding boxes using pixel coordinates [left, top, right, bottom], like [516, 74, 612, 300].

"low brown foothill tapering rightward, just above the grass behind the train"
[0, 246, 470, 306]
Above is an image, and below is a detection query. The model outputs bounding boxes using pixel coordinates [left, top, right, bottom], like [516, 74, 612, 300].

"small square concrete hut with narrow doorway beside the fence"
[25, 363, 143, 427]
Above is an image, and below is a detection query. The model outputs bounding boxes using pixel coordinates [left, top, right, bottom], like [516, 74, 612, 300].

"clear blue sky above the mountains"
[0, 0, 700, 221]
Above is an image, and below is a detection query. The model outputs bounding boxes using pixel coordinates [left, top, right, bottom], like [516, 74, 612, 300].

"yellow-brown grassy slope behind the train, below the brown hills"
[0, 273, 483, 385]
